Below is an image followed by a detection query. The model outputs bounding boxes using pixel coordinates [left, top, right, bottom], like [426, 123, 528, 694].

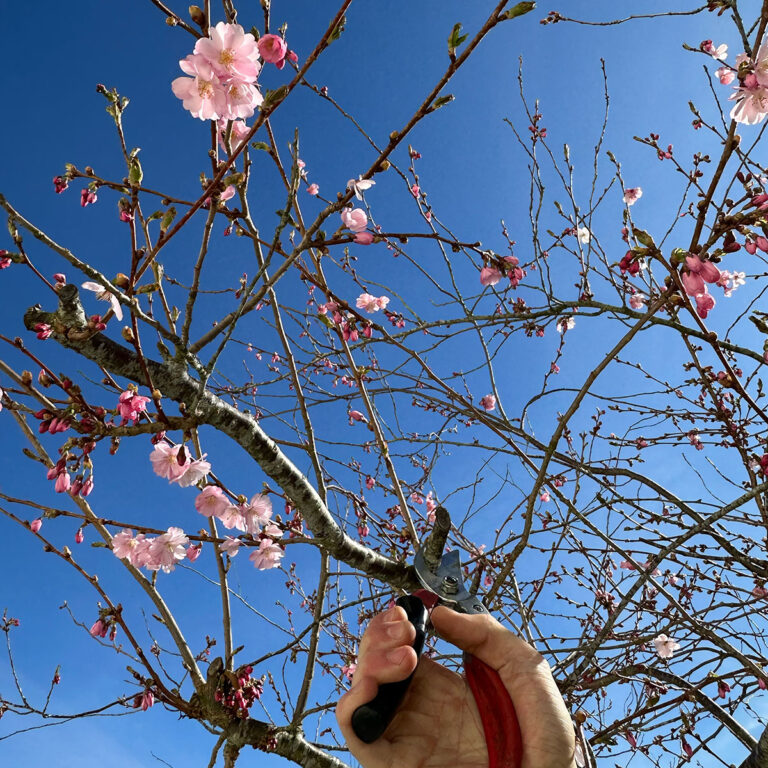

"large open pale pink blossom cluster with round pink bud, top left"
[171, 21, 297, 120]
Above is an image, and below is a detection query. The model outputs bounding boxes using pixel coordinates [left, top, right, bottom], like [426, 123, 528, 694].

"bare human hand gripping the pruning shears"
[336, 606, 575, 768]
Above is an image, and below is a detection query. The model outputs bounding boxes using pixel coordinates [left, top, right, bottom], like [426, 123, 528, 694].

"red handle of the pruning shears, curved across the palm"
[464, 653, 523, 768]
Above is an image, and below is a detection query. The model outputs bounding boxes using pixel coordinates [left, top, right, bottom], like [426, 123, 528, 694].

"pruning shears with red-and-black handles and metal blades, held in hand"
[352, 507, 522, 768]
